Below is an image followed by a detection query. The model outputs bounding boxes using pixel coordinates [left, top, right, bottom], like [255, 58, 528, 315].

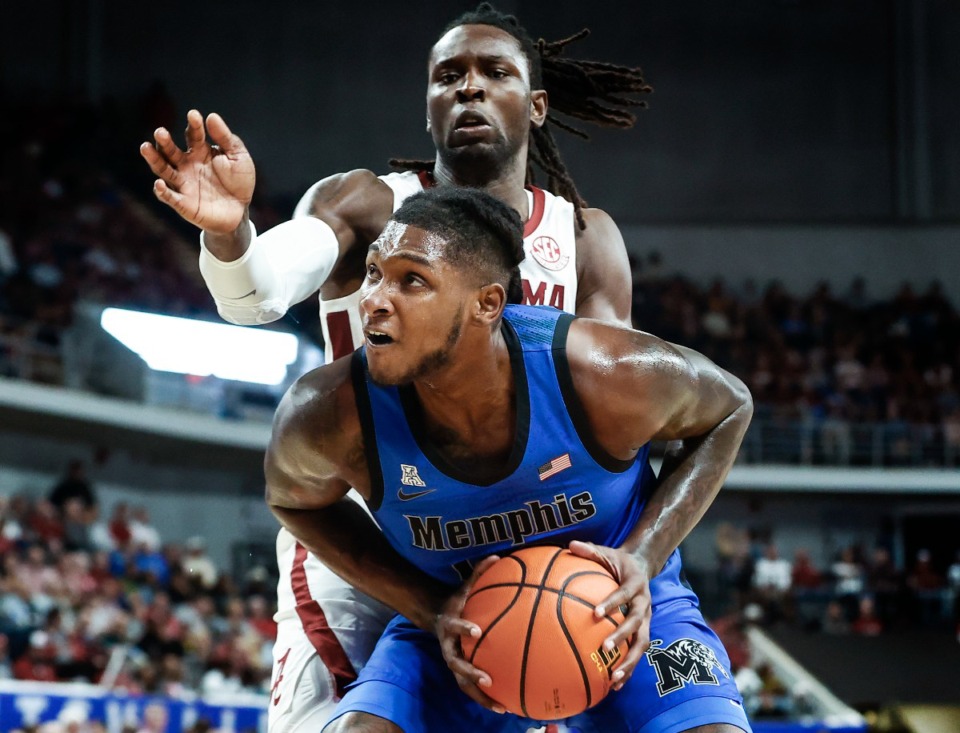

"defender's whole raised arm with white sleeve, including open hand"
[140, 110, 393, 324]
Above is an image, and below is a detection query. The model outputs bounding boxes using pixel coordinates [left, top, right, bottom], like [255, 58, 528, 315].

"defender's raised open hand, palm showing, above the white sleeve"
[140, 109, 256, 234]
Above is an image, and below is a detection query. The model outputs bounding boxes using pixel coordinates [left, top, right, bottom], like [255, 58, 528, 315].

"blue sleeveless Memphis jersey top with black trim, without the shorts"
[354, 305, 693, 602]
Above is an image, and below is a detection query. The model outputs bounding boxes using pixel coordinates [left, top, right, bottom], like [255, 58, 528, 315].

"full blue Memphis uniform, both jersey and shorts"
[333, 306, 750, 733]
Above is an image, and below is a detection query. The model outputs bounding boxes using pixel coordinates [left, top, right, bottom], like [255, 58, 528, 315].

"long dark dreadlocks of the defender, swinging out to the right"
[390, 2, 653, 229]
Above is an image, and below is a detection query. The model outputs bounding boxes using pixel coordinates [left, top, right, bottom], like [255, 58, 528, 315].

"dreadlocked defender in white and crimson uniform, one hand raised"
[141, 3, 649, 733]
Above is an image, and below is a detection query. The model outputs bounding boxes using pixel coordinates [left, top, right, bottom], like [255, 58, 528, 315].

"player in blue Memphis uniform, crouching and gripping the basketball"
[265, 187, 752, 733]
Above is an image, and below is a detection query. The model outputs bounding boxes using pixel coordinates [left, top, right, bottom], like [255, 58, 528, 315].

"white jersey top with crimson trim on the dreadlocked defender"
[320, 166, 577, 363]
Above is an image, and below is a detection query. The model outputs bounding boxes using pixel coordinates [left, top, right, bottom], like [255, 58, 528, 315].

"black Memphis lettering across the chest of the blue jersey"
[404, 491, 597, 550]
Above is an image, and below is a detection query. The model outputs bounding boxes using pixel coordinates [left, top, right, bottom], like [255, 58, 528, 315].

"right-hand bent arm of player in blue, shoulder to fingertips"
[567, 321, 753, 687]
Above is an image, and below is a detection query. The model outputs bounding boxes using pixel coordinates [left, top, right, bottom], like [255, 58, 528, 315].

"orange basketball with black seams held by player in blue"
[461, 546, 628, 720]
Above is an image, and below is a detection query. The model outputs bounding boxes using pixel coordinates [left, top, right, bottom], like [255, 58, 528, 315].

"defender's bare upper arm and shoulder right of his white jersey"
[576, 209, 633, 326]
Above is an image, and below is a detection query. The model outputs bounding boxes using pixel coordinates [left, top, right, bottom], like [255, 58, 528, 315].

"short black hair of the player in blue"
[391, 186, 524, 303]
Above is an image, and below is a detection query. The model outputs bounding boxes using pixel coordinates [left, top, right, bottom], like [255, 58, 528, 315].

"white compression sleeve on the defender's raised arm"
[200, 216, 340, 326]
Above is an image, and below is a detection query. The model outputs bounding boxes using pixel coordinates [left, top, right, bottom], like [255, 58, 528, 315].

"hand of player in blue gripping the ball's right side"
[569, 540, 653, 690]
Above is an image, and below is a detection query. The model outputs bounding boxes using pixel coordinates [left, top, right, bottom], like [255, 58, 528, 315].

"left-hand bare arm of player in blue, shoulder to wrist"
[264, 364, 451, 631]
